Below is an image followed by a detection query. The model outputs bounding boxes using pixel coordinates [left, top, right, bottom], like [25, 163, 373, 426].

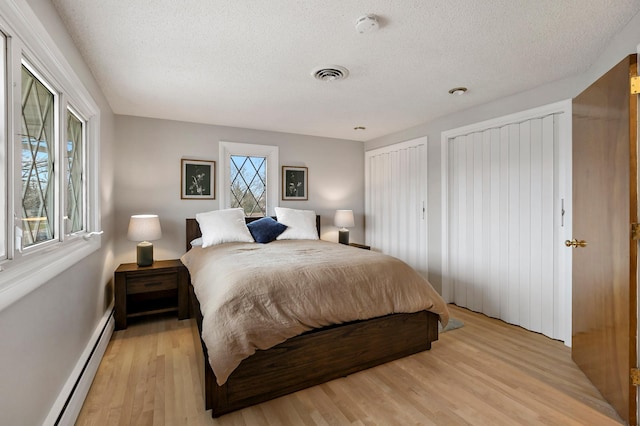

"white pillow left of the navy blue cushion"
[196, 208, 254, 248]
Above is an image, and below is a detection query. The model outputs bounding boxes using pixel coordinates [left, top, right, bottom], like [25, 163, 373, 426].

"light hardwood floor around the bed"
[77, 306, 622, 426]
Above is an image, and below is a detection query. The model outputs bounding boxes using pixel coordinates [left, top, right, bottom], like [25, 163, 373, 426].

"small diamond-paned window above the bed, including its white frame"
[219, 141, 278, 217]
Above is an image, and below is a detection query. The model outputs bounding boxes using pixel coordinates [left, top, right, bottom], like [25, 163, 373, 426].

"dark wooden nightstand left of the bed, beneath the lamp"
[114, 259, 189, 330]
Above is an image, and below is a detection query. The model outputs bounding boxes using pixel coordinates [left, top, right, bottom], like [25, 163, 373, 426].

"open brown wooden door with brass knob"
[571, 55, 637, 424]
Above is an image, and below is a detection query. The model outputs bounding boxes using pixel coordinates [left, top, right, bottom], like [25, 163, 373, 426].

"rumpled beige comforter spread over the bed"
[182, 240, 449, 385]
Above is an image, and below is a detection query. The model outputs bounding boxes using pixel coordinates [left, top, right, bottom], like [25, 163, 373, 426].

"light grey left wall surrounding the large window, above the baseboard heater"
[0, 0, 114, 425]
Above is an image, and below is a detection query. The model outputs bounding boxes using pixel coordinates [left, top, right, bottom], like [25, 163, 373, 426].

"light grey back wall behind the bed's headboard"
[115, 116, 364, 262]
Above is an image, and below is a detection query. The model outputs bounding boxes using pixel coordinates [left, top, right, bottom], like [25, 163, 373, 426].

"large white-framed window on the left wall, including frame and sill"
[0, 0, 101, 310]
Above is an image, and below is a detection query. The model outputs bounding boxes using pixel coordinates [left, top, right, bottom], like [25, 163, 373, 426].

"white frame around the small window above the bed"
[218, 141, 280, 216]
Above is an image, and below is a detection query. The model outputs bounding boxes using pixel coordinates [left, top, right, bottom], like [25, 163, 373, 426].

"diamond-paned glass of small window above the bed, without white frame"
[230, 155, 267, 217]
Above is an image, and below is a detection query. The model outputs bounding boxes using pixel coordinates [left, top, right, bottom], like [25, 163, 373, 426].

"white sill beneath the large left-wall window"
[0, 236, 101, 311]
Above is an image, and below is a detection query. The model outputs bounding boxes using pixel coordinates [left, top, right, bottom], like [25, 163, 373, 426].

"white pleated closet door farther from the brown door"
[365, 137, 428, 277]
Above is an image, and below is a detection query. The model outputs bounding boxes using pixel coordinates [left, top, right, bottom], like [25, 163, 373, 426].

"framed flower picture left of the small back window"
[180, 158, 216, 200]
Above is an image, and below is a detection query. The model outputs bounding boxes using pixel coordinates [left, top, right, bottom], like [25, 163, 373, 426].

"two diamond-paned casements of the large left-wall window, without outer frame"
[20, 64, 85, 249]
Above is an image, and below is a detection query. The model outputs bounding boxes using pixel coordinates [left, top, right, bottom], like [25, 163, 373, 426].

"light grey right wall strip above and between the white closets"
[365, 10, 640, 291]
